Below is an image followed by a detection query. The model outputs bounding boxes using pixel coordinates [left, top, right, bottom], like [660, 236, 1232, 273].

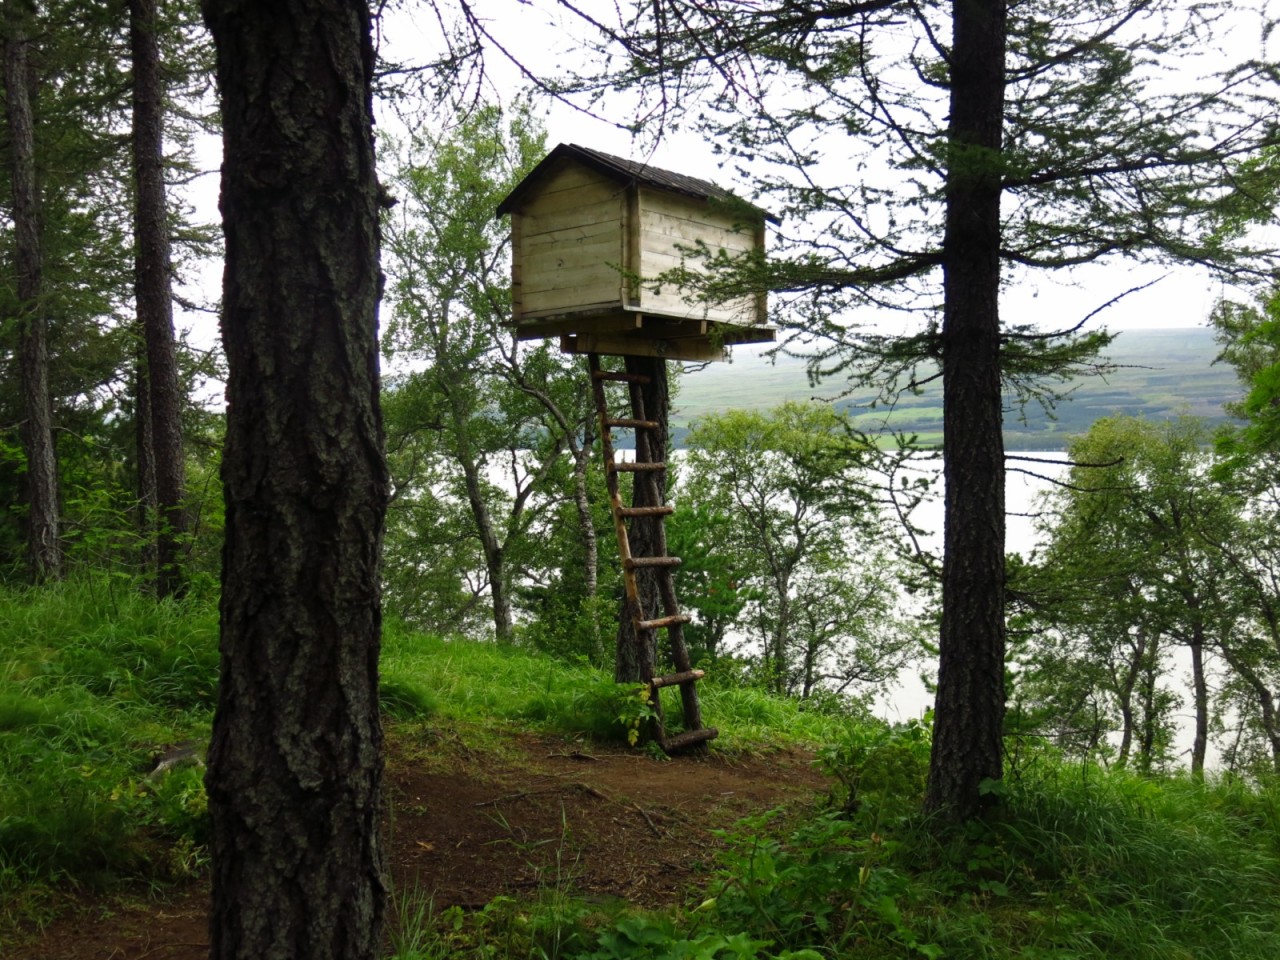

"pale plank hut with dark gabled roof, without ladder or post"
[498, 143, 777, 361]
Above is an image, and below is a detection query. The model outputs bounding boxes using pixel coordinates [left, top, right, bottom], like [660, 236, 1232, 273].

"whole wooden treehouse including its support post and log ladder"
[498, 143, 777, 754]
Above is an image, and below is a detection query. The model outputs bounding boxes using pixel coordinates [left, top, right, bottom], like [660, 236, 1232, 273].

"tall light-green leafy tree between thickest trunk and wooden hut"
[385, 108, 596, 641]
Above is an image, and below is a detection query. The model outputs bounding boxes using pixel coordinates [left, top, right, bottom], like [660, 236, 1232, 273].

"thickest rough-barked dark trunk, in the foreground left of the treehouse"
[204, 0, 388, 960]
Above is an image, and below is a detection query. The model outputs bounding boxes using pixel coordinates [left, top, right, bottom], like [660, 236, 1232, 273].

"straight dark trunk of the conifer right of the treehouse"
[925, 0, 1006, 819]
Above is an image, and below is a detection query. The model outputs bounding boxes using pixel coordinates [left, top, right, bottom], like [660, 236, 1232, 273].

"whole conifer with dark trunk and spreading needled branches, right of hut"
[570, 0, 1276, 819]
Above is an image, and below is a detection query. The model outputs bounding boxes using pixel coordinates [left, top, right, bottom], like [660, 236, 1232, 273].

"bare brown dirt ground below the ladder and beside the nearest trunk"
[5, 727, 827, 960]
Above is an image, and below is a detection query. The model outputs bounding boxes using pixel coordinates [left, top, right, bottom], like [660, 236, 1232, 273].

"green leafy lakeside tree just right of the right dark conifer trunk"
[1039, 417, 1247, 776]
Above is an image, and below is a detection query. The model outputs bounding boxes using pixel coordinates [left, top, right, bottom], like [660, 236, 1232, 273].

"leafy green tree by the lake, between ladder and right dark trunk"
[681, 403, 919, 698]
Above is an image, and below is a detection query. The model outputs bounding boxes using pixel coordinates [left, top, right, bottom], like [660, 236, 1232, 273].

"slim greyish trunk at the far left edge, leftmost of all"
[4, 3, 63, 582]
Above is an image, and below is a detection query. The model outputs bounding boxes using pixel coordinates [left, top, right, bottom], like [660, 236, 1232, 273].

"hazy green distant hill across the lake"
[671, 326, 1240, 451]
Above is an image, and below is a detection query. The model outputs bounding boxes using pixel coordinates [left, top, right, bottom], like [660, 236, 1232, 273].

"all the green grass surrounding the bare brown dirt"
[0, 581, 1280, 960]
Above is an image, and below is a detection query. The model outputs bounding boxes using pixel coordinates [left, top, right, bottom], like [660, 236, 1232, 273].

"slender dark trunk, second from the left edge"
[129, 0, 187, 596]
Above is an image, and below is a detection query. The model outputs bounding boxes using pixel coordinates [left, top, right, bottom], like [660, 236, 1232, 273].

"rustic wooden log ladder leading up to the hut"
[586, 353, 719, 754]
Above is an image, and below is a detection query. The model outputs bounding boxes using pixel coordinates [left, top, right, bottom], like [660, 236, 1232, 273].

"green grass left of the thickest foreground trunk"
[0, 577, 218, 919]
